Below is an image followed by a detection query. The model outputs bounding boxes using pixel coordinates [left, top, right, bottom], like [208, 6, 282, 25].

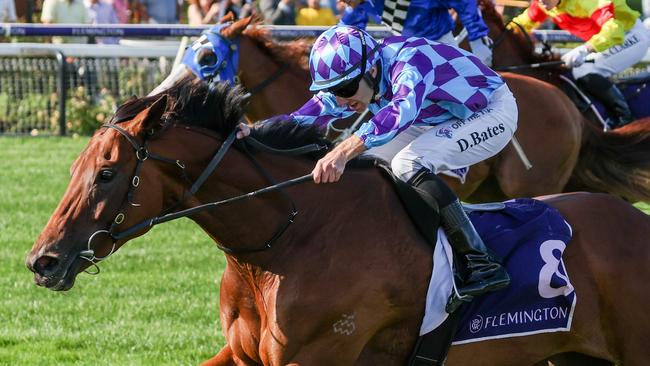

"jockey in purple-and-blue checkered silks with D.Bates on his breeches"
[238, 25, 517, 312]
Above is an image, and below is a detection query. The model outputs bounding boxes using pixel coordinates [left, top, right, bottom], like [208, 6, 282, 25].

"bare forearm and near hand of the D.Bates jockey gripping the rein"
[311, 135, 366, 183]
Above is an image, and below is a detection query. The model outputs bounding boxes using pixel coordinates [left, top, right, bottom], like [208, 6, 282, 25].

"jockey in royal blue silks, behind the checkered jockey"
[340, 0, 492, 65]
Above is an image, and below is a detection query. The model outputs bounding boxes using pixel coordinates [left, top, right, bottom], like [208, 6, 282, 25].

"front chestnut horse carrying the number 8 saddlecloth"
[26, 79, 650, 366]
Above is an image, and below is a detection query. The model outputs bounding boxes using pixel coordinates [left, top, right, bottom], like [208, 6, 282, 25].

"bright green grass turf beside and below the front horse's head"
[0, 137, 650, 365]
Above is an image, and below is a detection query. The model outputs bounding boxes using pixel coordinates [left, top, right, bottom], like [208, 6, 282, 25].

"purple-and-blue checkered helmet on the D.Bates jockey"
[309, 25, 378, 92]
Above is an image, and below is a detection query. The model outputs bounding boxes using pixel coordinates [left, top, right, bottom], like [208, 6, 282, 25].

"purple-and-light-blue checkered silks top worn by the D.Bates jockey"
[291, 37, 504, 148]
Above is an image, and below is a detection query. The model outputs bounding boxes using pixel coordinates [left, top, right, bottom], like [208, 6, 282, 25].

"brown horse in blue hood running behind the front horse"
[155, 18, 650, 202]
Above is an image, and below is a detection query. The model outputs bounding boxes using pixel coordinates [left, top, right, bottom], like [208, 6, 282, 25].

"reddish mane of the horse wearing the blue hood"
[243, 26, 311, 70]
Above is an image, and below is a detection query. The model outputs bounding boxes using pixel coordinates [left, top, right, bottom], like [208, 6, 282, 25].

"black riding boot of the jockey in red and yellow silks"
[577, 74, 634, 130]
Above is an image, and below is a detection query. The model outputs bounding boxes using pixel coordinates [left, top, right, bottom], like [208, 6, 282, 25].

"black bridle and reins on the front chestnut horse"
[79, 123, 327, 274]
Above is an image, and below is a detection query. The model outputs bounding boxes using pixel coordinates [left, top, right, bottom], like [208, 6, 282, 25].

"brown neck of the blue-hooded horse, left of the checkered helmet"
[239, 35, 311, 121]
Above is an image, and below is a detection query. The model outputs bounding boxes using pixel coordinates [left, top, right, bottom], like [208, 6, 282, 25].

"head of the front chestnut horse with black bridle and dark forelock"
[26, 78, 246, 290]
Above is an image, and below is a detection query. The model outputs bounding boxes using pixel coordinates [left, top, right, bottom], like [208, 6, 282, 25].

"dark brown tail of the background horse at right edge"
[573, 118, 650, 202]
